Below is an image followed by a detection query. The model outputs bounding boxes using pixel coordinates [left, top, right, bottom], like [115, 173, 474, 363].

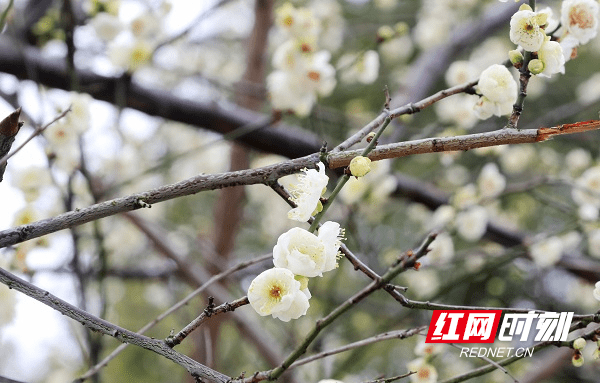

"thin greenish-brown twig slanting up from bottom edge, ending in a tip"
[268, 234, 436, 380]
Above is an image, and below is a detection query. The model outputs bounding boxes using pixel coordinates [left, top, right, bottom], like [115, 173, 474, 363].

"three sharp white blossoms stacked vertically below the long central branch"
[248, 162, 343, 322]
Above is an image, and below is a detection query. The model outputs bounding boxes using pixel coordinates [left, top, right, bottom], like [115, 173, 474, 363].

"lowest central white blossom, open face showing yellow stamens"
[248, 268, 309, 322]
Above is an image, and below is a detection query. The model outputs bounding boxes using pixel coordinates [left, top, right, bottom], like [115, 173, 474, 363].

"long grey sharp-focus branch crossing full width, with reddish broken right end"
[0, 120, 600, 248]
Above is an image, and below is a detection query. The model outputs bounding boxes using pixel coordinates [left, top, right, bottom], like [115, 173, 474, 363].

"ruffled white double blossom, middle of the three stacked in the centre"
[273, 221, 342, 277]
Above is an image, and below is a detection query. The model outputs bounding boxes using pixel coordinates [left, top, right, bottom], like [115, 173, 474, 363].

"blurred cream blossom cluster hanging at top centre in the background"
[266, 3, 336, 116]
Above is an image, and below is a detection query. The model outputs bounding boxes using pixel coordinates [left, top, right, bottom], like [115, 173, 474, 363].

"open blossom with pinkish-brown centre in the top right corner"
[560, 0, 600, 44]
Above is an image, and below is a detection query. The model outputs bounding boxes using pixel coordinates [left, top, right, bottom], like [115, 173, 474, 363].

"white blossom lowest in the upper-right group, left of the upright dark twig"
[475, 64, 517, 119]
